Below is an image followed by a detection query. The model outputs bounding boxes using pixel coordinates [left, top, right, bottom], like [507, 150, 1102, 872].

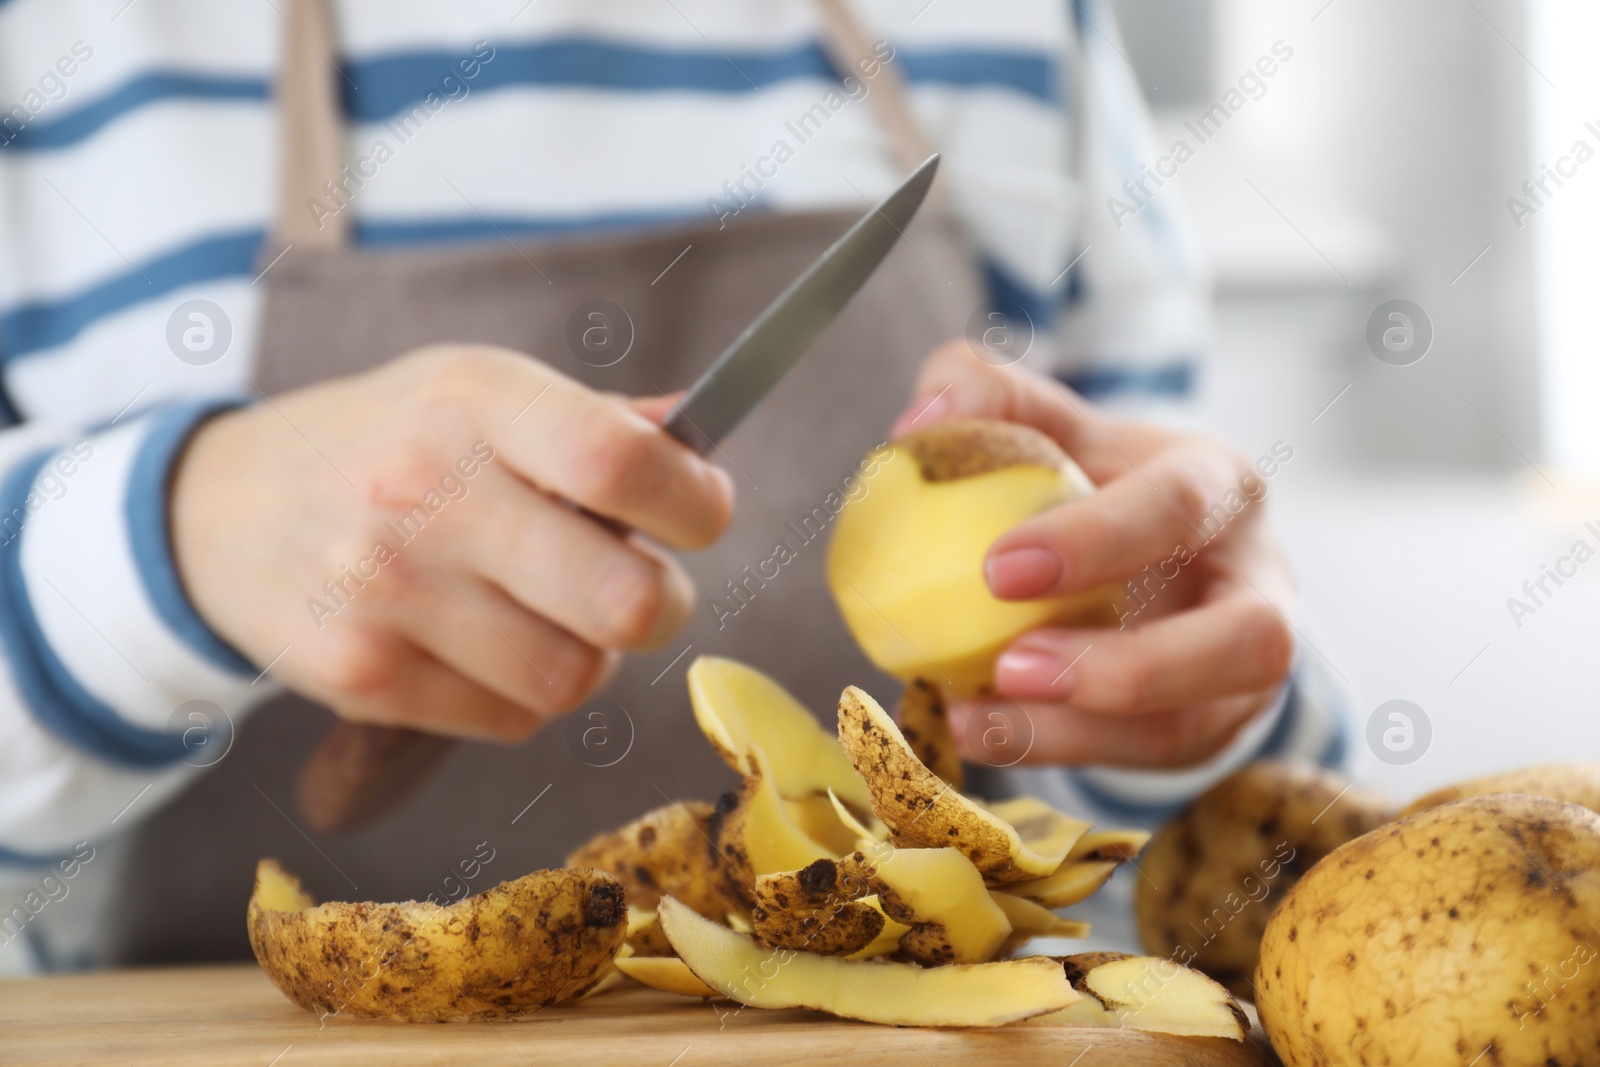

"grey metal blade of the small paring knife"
[662, 152, 939, 456]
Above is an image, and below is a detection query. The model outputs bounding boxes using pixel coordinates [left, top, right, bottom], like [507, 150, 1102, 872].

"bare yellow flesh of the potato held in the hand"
[827, 454, 1106, 696]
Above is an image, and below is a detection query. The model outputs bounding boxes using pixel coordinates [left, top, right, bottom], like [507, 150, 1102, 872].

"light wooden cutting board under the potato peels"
[0, 965, 1278, 1067]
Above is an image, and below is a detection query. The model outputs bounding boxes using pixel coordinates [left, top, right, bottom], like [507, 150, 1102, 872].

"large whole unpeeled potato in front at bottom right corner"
[1256, 793, 1600, 1067]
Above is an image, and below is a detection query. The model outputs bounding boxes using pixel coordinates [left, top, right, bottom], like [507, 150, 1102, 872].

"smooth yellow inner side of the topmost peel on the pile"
[688, 656, 870, 811]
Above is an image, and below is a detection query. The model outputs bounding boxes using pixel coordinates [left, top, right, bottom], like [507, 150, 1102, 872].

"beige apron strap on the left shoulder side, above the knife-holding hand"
[274, 0, 350, 248]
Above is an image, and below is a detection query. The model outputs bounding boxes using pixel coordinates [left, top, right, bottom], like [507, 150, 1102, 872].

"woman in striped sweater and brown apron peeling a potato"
[0, 0, 1339, 966]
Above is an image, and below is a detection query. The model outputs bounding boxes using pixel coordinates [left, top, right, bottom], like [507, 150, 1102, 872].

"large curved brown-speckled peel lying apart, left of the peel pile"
[248, 859, 624, 1022]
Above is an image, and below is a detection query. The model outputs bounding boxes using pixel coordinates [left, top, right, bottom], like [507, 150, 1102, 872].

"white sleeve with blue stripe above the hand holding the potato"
[1056, 0, 1211, 408]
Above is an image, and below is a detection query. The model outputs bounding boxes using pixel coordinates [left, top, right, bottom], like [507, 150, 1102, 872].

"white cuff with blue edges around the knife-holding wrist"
[0, 400, 269, 768]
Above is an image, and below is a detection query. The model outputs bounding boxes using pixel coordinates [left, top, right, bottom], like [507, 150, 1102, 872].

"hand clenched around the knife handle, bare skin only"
[170, 346, 733, 741]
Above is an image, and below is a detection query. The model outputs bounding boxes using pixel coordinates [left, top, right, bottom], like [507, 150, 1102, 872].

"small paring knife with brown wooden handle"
[294, 154, 939, 833]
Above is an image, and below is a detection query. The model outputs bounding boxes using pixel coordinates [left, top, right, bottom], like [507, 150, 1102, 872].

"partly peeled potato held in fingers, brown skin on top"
[827, 419, 1118, 696]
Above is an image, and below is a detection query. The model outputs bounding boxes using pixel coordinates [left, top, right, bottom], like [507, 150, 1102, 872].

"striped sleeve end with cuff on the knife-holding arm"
[0, 400, 272, 867]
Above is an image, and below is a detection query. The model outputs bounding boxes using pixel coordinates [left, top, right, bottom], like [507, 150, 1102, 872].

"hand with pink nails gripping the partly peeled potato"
[894, 341, 1294, 768]
